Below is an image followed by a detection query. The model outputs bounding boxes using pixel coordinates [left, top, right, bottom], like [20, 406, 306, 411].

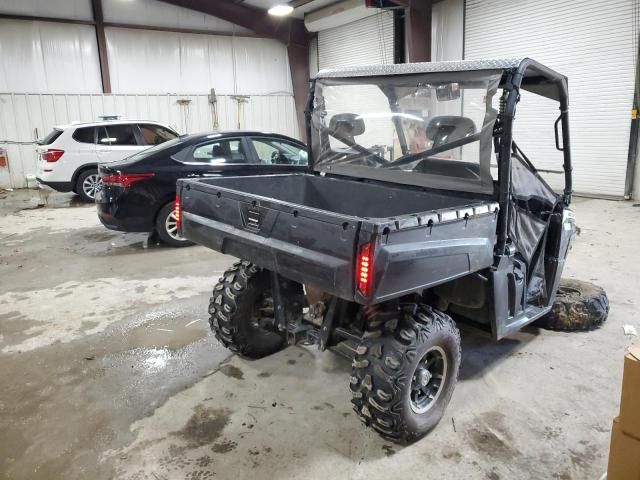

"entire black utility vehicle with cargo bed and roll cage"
[178, 58, 606, 441]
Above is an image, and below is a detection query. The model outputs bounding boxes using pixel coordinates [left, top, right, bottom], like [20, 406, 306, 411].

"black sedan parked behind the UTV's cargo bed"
[96, 130, 307, 247]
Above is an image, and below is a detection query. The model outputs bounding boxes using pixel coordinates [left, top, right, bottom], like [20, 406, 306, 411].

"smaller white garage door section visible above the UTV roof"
[318, 12, 393, 69]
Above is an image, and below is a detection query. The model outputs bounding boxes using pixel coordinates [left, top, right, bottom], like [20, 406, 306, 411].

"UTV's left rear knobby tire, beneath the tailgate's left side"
[209, 261, 302, 358]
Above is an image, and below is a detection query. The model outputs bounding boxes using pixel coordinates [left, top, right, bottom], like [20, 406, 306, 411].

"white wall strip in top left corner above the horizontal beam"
[0, 0, 92, 20]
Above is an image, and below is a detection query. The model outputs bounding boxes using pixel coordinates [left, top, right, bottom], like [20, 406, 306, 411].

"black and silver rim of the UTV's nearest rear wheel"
[410, 346, 449, 413]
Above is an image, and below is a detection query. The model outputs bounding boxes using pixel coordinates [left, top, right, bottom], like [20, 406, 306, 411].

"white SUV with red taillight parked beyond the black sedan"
[36, 120, 178, 201]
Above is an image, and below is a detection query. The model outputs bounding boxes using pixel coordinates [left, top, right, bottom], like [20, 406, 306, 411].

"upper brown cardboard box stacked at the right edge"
[620, 344, 640, 440]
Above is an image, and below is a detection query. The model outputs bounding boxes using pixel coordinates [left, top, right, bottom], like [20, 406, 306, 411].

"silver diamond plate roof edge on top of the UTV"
[316, 58, 524, 78]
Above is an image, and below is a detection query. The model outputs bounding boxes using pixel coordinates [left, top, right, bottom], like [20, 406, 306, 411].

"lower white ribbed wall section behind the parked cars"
[0, 94, 300, 188]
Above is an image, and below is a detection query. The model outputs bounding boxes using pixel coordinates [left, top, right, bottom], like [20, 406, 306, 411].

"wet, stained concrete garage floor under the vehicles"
[0, 191, 640, 480]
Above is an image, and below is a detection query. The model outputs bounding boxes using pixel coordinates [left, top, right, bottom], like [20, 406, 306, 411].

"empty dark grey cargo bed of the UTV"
[178, 174, 498, 304]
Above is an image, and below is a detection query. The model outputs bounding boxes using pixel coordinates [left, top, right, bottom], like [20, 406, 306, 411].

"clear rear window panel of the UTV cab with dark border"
[311, 71, 501, 193]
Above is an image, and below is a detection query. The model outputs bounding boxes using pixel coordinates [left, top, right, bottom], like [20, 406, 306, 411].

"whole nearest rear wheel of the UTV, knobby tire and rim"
[350, 304, 461, 443]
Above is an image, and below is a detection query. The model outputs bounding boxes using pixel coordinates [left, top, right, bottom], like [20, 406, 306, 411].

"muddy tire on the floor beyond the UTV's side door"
[537, 279, 609, 332]
